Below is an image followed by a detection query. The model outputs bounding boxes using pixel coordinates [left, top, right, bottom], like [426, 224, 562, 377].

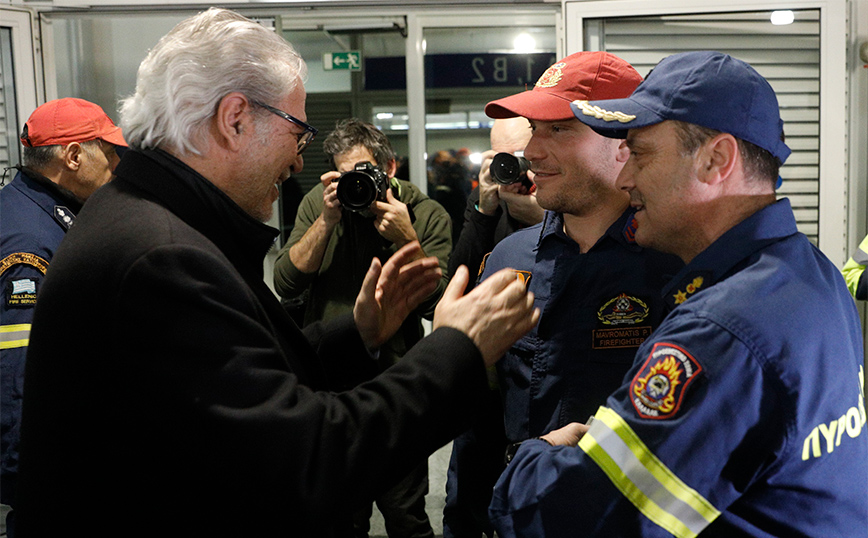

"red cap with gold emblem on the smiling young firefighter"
[485, 52, 642, 121]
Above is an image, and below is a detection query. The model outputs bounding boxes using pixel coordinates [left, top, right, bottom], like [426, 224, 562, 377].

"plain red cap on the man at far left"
[21, 97, 127, 148]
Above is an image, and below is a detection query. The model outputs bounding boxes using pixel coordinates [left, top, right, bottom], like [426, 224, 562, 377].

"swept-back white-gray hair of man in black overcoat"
[120, 8, 307, 154]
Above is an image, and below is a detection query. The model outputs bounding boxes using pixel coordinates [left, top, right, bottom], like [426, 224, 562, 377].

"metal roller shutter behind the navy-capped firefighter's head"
[585, 10, 820, 244]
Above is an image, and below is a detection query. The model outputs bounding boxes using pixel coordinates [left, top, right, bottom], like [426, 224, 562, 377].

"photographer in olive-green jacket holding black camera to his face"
[274, 119, 452, 538]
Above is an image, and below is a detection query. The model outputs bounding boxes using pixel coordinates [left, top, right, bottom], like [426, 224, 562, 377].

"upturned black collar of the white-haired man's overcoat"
[115, 149, 279, 279]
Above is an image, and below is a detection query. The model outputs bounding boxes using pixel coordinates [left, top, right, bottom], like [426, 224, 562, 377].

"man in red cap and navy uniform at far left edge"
[0, 98, 126, 536]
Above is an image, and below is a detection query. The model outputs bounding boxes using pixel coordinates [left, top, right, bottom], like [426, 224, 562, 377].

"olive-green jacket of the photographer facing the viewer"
[274, 179, 452, 367]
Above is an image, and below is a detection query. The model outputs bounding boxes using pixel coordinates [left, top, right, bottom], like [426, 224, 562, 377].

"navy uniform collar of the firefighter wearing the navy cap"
[662, 198, 799, 310]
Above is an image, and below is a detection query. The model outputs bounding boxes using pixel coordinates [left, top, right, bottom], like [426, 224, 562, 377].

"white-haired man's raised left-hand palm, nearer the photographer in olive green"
[353, 241, 442, 349]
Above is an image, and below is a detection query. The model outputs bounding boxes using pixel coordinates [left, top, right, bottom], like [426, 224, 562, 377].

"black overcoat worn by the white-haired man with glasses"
[17, 150, 486, 538]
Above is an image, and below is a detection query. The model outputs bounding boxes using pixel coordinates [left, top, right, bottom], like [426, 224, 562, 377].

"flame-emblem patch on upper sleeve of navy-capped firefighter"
[630, 342, 702, 420]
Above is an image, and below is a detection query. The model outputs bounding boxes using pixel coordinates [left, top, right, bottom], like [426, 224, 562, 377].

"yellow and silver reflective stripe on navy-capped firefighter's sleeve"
[579, 407, 720, 538]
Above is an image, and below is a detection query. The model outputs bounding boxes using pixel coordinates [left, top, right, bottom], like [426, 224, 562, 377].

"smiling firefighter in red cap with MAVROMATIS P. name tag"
[448, 52, 681, 532]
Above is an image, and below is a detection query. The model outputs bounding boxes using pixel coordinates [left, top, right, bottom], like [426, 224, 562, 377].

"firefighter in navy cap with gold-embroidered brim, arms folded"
[491, 51, 868, 538]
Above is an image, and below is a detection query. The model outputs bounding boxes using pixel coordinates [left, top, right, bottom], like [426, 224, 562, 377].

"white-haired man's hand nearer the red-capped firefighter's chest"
[434, 265, 540, 366]
